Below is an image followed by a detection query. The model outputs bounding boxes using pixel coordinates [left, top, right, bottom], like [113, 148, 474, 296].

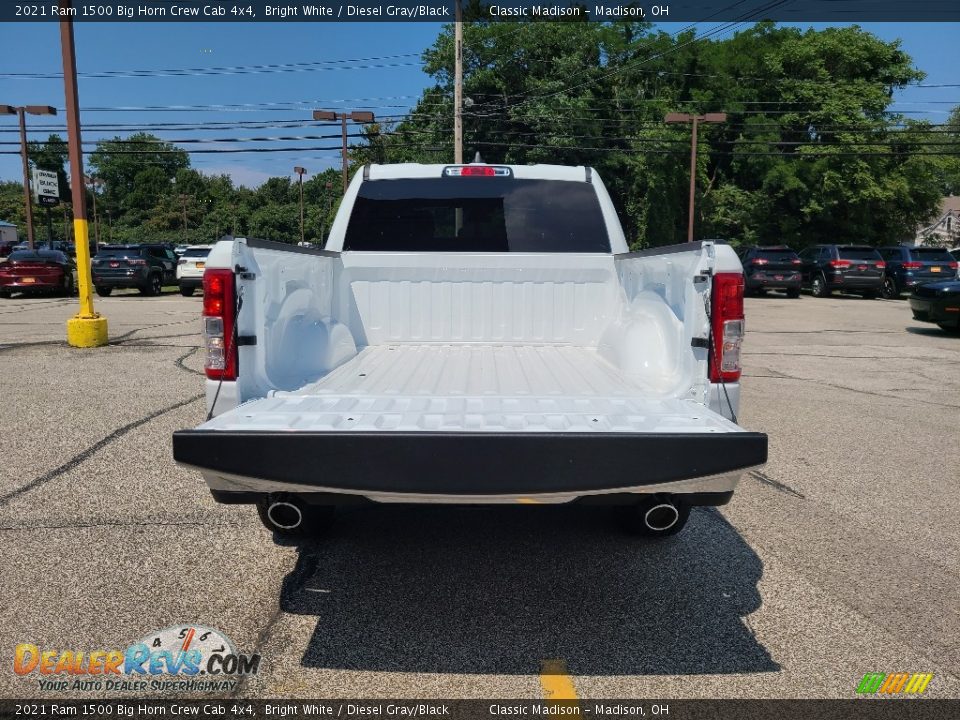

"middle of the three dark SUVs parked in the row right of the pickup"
[800, 245, 886, 298]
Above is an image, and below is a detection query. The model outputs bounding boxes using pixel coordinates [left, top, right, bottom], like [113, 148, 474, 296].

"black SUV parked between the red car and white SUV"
[92, 245, 177, 297]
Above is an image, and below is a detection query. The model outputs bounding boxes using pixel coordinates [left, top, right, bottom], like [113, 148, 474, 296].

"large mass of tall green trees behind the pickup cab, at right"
[378, 22, 940, 246]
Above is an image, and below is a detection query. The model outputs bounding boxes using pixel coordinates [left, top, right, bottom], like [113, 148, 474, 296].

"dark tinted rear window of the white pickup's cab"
[343, 177, 610, 253]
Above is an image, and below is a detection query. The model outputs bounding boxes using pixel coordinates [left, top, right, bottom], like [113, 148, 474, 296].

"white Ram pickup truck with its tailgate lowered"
[173, 164, 767, 536]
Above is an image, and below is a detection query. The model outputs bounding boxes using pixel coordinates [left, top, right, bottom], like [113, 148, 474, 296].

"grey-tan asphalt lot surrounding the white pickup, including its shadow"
[0, 286, 960, 699]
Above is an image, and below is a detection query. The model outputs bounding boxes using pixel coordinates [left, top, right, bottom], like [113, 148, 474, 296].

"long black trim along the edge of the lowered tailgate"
[173, 430, 767, 495]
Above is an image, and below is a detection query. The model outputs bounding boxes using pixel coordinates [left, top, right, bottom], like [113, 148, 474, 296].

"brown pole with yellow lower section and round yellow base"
[59, 0, 109, 347]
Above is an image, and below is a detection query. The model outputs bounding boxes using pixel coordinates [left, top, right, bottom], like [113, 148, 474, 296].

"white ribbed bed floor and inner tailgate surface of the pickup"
[202, 345, 739, 433]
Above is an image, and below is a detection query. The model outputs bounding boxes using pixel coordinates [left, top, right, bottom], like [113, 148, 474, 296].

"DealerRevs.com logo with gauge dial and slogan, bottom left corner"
[13, 625, 260, 692]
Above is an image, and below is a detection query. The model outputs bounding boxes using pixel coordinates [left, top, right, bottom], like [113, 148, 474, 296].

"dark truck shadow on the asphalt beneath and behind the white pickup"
[280, 506, 779, 675]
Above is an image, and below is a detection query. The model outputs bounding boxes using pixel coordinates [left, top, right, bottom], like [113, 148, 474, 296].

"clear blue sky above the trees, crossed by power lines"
[0, 22, 960, 186]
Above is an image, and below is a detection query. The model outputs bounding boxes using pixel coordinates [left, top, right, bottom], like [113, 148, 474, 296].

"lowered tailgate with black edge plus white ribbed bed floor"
[174, 345, 767, 497]
